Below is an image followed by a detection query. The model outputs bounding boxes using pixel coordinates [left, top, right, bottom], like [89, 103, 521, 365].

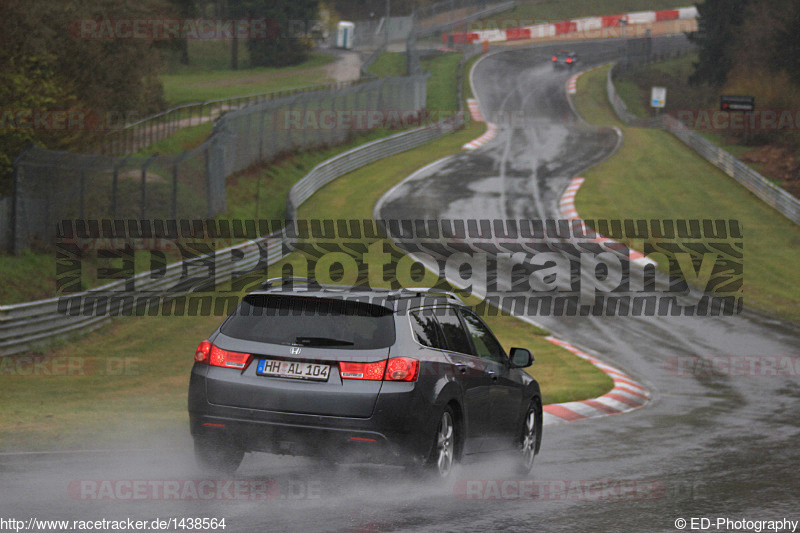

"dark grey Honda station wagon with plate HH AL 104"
[189, 278, 542, 477]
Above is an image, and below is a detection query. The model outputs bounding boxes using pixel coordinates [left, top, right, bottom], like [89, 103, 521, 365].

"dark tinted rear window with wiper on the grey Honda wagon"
[221, 294, 395, 350]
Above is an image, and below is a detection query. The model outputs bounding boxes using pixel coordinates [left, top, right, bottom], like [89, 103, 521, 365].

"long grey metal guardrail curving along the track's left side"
[0, 115, 463, 356]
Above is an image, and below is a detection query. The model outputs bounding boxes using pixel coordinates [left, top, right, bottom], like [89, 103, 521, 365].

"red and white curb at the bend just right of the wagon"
[543, 337, 650, 426]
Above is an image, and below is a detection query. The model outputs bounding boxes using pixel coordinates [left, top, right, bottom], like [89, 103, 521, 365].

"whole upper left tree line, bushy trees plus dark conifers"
[0, 0, 319, 195]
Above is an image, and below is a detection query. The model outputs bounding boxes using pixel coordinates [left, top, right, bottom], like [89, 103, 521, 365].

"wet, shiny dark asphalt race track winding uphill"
[0, 37, 800, 533]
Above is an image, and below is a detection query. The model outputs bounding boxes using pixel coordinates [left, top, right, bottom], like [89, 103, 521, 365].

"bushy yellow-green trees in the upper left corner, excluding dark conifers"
[0, 0, 171, 194]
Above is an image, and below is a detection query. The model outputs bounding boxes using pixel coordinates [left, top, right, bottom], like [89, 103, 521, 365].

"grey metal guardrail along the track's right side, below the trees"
[606, 63, 800, 225]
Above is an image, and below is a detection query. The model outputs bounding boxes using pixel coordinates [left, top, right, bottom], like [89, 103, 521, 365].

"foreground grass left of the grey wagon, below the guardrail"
[0, 317, 220, 451]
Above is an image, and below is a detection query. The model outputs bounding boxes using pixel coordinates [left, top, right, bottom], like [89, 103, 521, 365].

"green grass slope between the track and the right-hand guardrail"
[575, 62, 800, 321]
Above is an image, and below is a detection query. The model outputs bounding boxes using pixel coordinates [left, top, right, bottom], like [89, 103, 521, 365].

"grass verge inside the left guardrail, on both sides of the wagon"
[0, 52, 611, 451]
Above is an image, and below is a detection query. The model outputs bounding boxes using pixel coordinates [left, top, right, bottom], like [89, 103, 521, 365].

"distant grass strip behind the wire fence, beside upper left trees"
[161, 54, 334, 106]
